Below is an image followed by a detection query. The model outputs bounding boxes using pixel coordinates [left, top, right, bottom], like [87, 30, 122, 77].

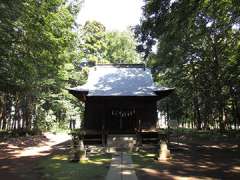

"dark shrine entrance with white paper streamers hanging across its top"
[107, 108, 137, 134]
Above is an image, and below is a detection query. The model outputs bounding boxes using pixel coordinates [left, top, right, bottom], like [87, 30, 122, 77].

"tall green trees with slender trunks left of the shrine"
[0, 0, 81, 130]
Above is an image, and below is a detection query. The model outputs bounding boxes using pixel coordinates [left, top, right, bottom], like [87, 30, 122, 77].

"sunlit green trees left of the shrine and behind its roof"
[0, 0, 140, 131]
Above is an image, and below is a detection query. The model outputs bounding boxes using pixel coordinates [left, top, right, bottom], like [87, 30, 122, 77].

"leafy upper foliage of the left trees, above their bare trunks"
[1, 0, 73, 92]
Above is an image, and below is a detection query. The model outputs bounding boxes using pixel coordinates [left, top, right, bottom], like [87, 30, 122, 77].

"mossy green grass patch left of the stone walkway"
[39, 154, 111, 180]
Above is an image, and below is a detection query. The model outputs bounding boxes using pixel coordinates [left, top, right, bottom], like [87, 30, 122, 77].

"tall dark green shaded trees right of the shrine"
[135, 0, 240, 130]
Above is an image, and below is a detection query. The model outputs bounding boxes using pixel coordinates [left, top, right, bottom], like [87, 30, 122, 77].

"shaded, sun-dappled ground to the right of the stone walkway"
[133, 143, 240, 180]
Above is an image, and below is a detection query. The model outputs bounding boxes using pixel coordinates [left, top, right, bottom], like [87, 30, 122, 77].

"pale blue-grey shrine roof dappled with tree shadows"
[69, 65, 172, 96]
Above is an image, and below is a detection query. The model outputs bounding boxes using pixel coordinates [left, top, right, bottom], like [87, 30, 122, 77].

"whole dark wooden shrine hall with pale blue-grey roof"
[68, 64, 173, 147]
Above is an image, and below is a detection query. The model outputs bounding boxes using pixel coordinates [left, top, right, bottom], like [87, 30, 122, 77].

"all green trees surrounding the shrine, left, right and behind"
[0, 0, 240, 134]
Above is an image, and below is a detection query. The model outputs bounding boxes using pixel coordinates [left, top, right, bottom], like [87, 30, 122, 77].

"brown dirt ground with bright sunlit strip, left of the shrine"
[0, 133, 70, 180]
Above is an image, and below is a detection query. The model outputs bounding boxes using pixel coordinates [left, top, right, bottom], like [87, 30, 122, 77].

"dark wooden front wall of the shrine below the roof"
[83, 97, 157, 131]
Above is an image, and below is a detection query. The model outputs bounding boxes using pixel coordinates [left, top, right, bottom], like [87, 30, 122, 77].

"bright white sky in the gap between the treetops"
[77, 0, 143, 31]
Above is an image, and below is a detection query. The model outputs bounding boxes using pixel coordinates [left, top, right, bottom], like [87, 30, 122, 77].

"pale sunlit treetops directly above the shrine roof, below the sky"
[78, 21, 141, 64]
